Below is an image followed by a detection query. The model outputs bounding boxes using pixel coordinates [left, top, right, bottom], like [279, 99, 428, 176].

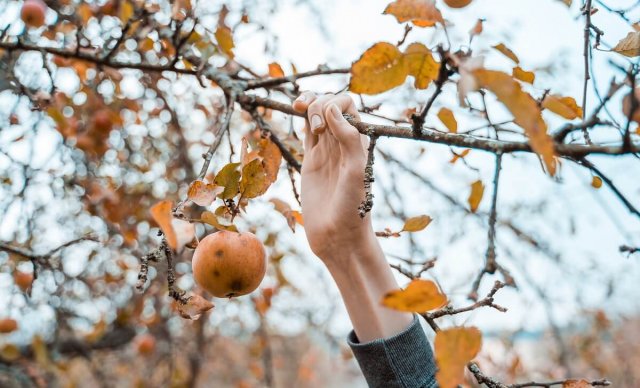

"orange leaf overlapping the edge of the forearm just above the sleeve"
[382, 279, 447, 313]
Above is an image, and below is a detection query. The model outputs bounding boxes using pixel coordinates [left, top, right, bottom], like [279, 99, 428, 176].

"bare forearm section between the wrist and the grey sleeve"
[323, 232, 413, 342]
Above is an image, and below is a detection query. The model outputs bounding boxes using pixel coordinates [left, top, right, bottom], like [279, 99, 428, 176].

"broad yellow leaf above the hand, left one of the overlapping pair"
[349, 42, 408, 94]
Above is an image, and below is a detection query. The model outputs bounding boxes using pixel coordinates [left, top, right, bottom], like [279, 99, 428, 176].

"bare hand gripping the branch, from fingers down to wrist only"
[293, 92, 375, 264]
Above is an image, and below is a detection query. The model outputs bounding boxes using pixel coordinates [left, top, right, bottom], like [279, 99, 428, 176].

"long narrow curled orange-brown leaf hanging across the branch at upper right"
[473, 69, 556, 176]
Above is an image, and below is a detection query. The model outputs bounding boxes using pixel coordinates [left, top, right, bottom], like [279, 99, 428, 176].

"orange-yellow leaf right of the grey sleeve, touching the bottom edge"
[434, 327, 482, 388]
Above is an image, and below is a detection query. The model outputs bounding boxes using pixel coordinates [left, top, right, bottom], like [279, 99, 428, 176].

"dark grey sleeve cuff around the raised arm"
[347, 315, 438, 388]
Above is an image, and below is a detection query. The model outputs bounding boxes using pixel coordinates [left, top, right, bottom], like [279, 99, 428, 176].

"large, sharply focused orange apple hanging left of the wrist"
[191, 230, 267, 298]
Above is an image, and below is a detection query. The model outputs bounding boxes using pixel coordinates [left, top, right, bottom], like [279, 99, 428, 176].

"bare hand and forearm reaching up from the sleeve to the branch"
[293, 92, 412, 342]
